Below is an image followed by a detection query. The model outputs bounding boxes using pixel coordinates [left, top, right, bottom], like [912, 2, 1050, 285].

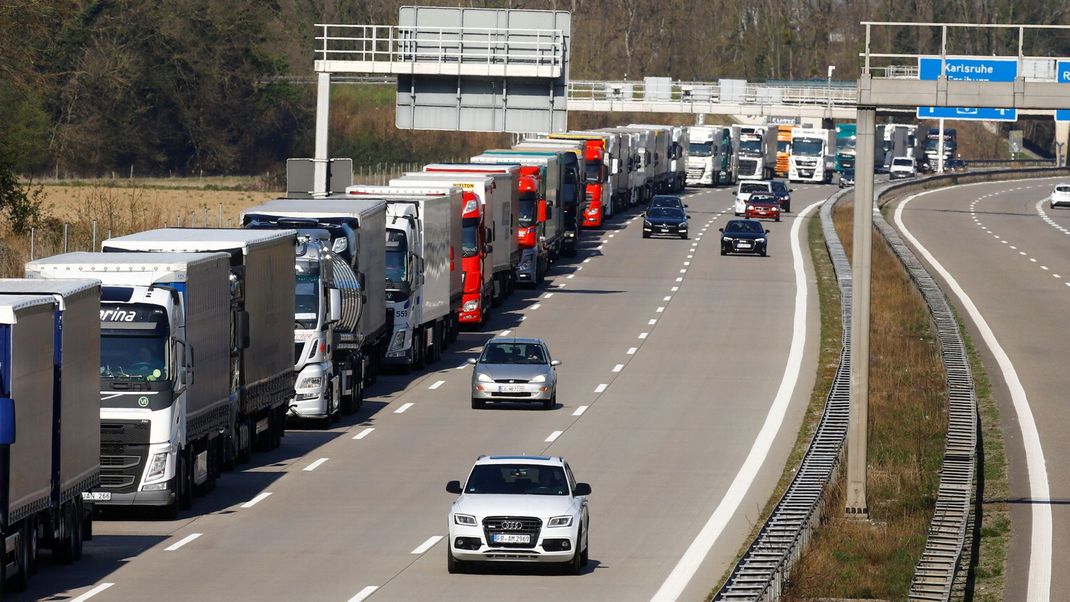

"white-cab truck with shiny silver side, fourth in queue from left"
[242, 197, 388, 422]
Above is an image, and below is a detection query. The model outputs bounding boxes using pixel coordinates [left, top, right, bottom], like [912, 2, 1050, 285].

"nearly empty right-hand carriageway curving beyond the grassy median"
[898, 179, 1070, 601]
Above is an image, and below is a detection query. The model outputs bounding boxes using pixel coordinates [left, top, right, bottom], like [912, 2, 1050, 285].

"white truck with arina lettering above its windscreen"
[26, 252, 236, 515]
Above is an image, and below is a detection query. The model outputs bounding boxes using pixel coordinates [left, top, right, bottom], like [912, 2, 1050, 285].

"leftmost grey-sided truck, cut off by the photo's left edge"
[0, 279, 101, 595]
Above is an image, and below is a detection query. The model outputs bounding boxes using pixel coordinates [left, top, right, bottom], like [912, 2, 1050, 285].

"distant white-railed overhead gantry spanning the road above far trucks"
[568, 80, 858, 107]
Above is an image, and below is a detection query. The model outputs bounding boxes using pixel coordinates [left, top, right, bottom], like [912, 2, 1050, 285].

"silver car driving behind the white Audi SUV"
[469, 338, 561, 410]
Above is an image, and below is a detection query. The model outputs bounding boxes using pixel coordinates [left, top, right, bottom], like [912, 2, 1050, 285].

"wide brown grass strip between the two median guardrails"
[784, 202, 947, 600]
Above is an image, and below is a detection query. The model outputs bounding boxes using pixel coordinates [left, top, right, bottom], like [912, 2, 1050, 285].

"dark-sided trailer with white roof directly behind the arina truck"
[103, 228, 296, 462]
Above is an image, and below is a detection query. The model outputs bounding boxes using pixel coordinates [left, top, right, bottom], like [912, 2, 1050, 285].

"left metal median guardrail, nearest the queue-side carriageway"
[714, 190, 853, 602]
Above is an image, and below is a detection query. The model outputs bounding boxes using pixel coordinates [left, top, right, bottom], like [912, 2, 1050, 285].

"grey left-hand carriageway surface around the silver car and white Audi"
[16, 185, 834, 602]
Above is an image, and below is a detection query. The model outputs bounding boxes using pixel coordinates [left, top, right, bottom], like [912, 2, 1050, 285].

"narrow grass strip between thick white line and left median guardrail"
[707, 212, 843, 600]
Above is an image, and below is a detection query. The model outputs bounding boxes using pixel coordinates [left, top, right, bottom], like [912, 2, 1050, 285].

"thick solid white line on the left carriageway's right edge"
[651, 201, 824, 602]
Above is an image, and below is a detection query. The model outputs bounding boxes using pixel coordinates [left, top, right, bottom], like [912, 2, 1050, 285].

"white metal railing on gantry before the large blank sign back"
[316, 24, 565, 67]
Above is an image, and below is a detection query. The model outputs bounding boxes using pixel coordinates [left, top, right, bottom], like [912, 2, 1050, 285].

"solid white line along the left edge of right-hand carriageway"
[895, 192, 1052, 602]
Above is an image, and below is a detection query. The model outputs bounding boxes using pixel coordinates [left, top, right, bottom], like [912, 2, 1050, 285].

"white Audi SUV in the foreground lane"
[446, 456, 591, 574]
